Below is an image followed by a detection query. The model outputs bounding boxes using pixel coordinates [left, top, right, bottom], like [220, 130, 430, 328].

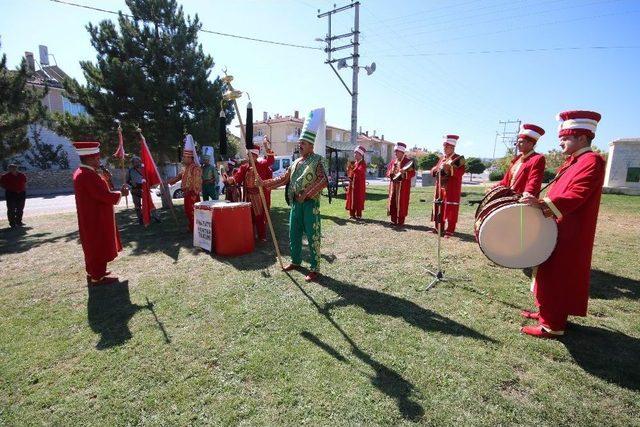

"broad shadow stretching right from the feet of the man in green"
[318, 276, 496, 343]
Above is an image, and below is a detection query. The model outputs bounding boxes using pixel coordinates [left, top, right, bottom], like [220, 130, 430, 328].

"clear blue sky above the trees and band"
[0, 0, 640, 157]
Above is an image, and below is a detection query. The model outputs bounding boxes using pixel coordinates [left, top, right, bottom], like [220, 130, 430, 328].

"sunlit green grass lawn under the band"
[0, 187, 640, 426]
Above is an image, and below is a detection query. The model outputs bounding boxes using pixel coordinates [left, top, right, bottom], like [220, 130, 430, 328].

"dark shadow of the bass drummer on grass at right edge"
[560, 324, 640, 391]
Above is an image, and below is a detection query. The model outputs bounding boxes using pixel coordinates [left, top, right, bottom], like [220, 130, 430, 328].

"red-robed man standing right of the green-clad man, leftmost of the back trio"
[387, 142, 416, 225]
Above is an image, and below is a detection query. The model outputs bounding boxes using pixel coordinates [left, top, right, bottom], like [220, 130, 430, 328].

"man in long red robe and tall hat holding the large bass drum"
[520, 111, 605, 338]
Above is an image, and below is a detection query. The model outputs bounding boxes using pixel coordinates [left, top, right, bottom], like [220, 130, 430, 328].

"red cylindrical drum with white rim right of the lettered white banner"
[212, 202, 255, 256]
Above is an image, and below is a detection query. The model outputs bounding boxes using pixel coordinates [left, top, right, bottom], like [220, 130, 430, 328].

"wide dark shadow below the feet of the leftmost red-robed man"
[87, 280, 147, 350]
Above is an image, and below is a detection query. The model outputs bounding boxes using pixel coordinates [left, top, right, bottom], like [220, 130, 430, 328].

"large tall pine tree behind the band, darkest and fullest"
[56, 0, 233, 161]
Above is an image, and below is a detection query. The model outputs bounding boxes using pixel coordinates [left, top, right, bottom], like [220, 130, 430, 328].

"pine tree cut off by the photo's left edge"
[0, 43, 47, 161]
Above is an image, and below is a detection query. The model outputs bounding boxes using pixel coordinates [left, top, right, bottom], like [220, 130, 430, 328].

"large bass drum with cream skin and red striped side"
[474, 186, 558, 268]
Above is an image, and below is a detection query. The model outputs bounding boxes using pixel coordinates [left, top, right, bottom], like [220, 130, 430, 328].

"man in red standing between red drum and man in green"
[222, 139, 275, 241]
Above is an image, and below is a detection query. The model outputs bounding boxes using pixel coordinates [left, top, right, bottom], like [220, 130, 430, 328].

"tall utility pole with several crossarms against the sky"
[316, 1, 376, 146]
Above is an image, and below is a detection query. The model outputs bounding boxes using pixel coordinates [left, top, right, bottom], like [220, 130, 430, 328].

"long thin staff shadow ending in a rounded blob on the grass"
[286, 273, 424, 421]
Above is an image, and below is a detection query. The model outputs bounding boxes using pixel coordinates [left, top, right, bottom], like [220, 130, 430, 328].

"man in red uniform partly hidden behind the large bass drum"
[494, 123, 546, 197]
